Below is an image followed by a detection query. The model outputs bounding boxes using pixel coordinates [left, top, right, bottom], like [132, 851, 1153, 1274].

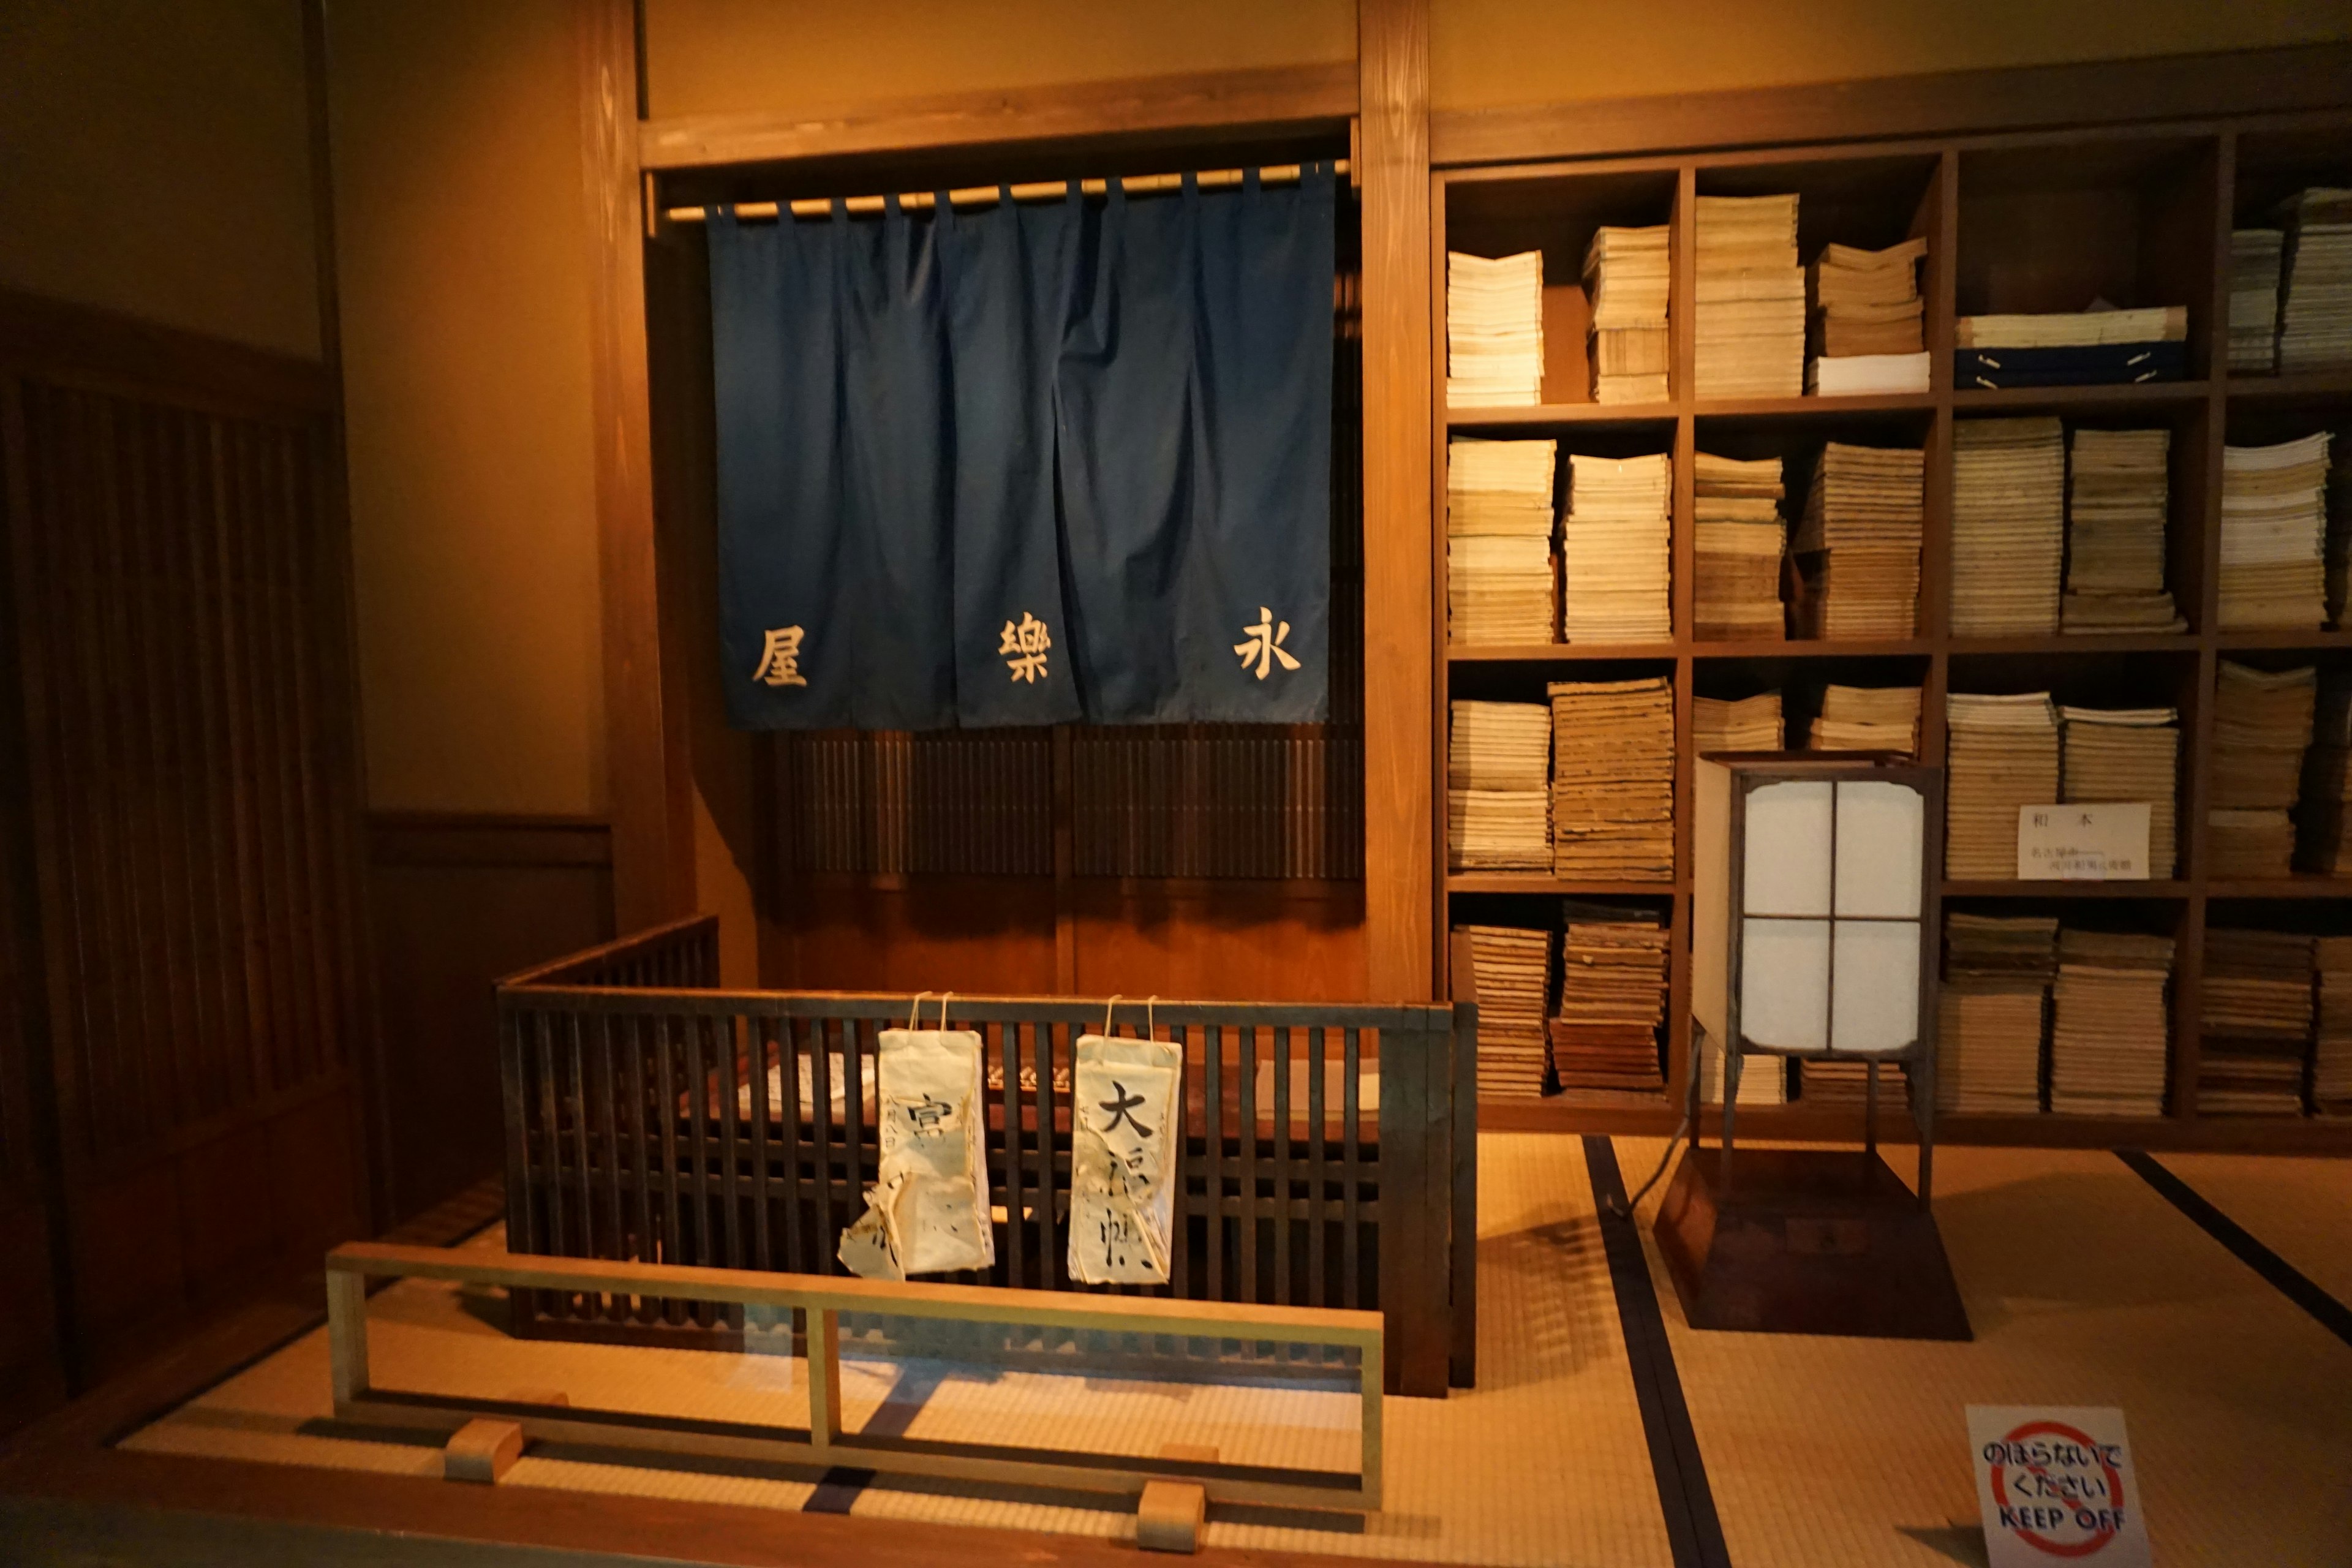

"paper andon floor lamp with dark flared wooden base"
[1656, 752, 1973, 1340]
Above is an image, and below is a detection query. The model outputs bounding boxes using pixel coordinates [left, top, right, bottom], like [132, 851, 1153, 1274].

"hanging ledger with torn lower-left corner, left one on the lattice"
[837, 1030, 997, 1279]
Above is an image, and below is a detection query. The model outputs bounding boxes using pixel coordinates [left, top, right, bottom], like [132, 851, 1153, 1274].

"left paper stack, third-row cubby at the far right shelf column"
[2206, 658, 2319, 879]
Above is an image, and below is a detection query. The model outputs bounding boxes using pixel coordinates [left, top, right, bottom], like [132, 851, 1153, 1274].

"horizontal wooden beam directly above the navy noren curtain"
[638, 61, 1357, 169]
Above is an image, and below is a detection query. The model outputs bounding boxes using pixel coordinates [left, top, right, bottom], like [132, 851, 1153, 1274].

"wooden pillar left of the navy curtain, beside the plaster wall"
[574, 0, 694, 931]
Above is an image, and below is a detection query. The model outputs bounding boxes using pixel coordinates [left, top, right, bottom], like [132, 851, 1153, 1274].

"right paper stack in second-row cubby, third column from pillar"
[2063, 430, 2187, 632]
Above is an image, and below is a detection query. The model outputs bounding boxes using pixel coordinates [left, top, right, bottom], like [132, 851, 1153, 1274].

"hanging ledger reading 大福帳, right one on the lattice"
[1070, 1035, 1183, 1286]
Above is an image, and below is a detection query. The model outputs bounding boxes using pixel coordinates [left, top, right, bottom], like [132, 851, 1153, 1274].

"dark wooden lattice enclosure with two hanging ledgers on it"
[499, 917, 1477, 1394]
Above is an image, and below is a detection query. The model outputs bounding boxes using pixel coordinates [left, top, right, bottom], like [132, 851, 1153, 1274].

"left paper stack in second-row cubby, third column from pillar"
[1952, 418, 2065, 637]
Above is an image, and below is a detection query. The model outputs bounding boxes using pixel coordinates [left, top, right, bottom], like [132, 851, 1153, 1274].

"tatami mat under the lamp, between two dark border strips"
[1618, 1140, 2352, 1568]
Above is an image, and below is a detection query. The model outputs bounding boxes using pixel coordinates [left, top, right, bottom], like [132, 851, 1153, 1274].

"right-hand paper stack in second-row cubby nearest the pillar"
[1559, 451, 1675, 642]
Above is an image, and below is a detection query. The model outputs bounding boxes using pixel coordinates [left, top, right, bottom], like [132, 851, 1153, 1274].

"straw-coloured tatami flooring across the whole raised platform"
[127, 1133, 2352, 1568]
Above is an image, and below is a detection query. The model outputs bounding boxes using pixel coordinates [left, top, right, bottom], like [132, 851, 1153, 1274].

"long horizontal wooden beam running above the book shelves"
[1430, 45, 2352, 167]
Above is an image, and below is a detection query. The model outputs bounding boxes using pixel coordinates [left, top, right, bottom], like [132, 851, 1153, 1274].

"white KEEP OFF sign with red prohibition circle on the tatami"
[1969, 1406, 2150, 1568]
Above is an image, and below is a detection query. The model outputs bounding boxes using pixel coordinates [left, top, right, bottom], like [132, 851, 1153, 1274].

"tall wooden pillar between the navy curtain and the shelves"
[1357, 0, 1439, 1001]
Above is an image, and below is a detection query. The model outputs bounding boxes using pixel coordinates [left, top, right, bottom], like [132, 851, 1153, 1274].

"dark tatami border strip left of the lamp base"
[1585, 1133, 1731, 1568]
